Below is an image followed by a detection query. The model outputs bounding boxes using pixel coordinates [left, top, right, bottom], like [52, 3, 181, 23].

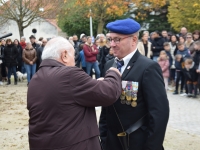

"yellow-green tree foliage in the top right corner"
[168, 0, 200, 32]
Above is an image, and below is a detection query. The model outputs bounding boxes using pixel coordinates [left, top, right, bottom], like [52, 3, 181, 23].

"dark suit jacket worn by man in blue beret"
[99, 51, 169, 150]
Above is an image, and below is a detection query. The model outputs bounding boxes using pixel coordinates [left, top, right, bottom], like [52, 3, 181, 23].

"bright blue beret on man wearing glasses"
[106, 18, 140, 34]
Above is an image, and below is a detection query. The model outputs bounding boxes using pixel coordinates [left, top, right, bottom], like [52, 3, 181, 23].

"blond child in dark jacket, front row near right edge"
[184, 58, 198, 98]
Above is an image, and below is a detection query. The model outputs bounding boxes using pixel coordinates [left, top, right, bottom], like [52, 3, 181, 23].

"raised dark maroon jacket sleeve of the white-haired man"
[70, 68, 121, 107]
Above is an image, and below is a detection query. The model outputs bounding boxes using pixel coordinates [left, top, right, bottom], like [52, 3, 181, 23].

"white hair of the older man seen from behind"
[42, 37, 74, 60]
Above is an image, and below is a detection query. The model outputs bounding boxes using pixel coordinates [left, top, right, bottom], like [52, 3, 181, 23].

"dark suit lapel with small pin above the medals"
[122, 50, 140, 80]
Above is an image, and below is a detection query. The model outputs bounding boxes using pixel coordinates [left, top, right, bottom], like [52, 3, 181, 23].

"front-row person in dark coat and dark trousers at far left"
[4, 39, 18, 85]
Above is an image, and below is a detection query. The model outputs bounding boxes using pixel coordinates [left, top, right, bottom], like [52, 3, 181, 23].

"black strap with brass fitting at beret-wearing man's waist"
[113, 105, 147, 150]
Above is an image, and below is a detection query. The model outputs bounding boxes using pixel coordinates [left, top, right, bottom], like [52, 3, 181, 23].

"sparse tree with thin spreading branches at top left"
[0, 0, 62, 37]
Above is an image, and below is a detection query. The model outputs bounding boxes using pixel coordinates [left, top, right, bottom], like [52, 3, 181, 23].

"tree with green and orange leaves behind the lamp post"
[59, 0, 128, 34]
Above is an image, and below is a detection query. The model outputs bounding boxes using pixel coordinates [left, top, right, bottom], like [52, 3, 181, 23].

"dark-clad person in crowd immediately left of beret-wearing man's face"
[99, 37, 110, 76]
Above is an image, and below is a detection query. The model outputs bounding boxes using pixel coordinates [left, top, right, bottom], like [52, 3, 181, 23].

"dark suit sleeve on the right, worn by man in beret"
[142, 62, 169, 150]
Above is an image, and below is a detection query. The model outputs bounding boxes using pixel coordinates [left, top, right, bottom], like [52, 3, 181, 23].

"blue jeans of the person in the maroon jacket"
[86, 62, 100, 79]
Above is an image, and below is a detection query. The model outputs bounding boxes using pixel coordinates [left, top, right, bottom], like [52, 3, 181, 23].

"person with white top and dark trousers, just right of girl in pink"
[169, 34, 178, 86]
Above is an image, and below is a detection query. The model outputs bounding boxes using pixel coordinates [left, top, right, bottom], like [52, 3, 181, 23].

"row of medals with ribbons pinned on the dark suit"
[120, 81, 138, 107]
